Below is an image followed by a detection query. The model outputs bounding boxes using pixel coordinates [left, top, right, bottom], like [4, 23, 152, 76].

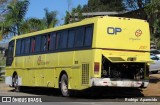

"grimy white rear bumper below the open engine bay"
[90, 78, 149, 88]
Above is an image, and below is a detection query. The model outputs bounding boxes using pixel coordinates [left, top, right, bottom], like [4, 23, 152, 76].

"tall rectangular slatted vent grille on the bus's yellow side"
[82, 64, 89, 84]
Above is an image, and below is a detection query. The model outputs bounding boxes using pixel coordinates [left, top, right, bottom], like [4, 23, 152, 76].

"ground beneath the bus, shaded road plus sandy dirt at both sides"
[0, 74, 160, 105]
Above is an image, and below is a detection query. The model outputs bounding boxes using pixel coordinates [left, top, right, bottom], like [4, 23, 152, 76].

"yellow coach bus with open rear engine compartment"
[5, 16, 151, 96]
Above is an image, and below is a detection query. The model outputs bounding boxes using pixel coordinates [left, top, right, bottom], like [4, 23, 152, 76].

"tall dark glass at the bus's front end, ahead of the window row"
[6, 40, 15, 66]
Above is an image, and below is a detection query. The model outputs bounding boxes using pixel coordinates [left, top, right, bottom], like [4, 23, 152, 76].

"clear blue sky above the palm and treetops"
[26, 0, 88, 25]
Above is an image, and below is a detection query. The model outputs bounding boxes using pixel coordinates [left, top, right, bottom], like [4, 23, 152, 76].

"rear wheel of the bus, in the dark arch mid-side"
[60, 74, 69, 97]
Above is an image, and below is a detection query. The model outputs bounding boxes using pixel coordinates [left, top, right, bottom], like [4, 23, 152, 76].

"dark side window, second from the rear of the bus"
[75, 27, 84, 47]
